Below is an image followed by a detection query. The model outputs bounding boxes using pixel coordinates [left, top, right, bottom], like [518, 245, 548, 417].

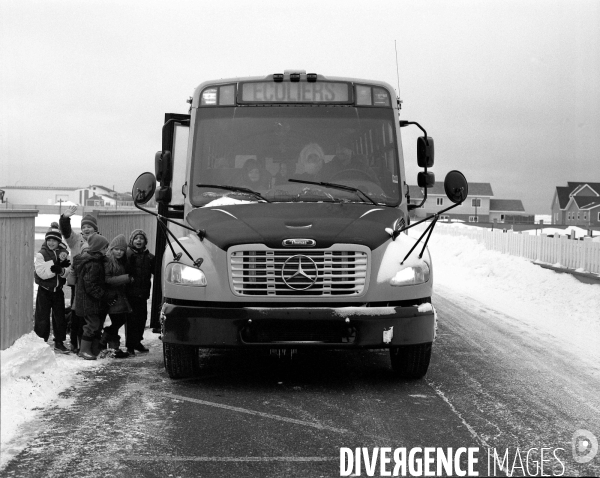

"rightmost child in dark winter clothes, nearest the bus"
[126, 229, 154, 355]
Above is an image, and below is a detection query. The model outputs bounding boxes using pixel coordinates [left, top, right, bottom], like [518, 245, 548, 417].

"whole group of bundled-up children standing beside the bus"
[34, 206, 154, 360]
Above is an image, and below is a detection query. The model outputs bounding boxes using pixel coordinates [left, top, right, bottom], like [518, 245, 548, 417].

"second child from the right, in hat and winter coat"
[100, 234, 133, 358]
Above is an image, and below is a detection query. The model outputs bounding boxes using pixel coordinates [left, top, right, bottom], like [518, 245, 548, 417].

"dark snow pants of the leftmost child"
[33, 286, 67, 342]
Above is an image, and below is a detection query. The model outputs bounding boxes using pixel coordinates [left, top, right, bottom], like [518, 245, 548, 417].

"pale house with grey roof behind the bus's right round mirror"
[409, 182, 494, 222]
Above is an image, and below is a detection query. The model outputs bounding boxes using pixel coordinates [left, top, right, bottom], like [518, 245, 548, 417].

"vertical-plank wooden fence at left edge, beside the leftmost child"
[0, 209, 38, 350]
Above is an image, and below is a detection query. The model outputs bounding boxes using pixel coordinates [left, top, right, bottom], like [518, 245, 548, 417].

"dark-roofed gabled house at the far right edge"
[551, 182, 600, 228]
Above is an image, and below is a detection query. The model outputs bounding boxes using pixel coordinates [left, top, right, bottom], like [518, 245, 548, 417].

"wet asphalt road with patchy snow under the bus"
[2, 287, 600, 477]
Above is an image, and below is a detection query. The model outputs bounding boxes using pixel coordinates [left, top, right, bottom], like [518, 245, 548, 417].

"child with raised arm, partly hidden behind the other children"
[59, 206, 98, 353]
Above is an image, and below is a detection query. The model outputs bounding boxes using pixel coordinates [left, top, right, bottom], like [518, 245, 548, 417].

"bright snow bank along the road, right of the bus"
[422, 228, 600, 367]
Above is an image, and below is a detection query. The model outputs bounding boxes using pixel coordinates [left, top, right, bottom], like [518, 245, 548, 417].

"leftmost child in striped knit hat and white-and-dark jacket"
[34, 227, 71, 354]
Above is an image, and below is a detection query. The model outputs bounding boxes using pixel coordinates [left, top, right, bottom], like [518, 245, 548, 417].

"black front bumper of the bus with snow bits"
[161, 303, 436, 348]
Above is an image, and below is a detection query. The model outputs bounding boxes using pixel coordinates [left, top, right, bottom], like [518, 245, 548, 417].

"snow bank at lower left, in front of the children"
[0, 332, 106, 468]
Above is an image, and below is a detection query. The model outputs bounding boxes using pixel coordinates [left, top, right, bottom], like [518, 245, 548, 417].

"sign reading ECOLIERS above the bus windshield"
[241, 81, 350, 103]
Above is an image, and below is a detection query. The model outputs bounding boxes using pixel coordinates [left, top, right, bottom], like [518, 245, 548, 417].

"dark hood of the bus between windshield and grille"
[186, 203, 406, 250]
